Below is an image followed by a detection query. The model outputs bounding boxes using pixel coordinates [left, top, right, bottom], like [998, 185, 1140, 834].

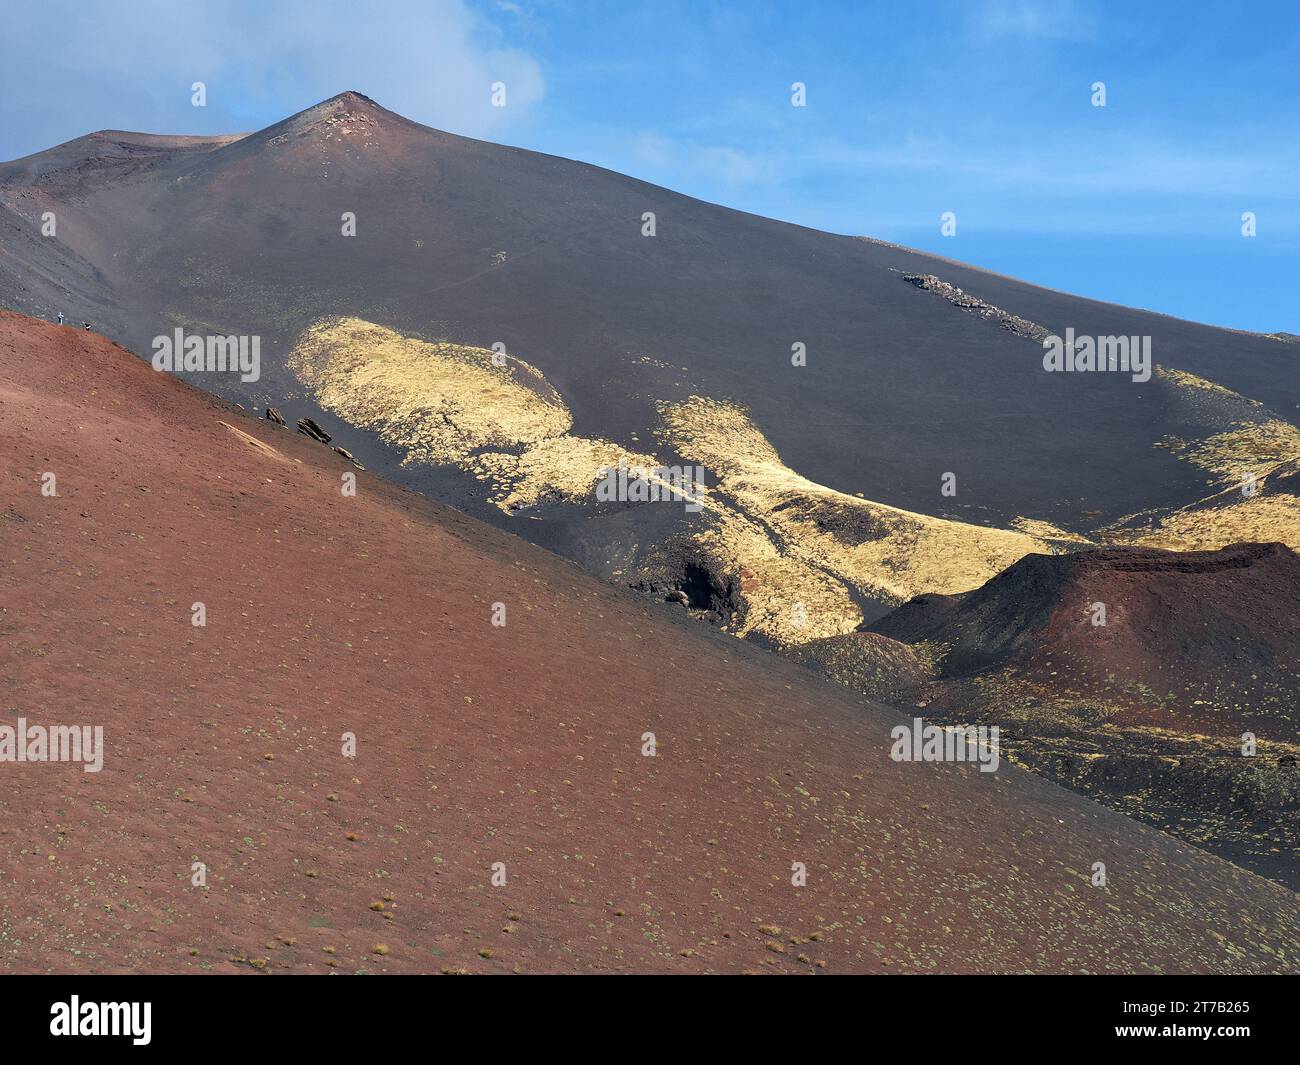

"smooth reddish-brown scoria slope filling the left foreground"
[0, 312, 1300, 973]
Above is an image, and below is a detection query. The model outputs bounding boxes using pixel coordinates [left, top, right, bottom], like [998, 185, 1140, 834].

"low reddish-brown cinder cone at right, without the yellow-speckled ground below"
[872, 544, 1300, 743]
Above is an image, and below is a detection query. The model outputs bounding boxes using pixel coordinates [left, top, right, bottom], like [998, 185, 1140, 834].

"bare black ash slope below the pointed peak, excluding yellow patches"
[0, 94, 1300, 525]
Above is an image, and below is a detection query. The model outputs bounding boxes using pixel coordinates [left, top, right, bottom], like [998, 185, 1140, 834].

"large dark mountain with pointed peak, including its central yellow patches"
[0, 92, 1300, 642]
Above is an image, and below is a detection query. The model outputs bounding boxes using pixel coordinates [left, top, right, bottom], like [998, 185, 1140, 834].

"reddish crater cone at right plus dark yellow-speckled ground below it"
[863, 540, 1300, 888]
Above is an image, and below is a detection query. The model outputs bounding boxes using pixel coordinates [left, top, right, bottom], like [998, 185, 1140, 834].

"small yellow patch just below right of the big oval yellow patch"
[463, 434, 659, 511]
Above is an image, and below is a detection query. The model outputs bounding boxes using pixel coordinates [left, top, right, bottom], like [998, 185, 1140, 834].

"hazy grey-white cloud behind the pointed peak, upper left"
[0, 0, 546, 157]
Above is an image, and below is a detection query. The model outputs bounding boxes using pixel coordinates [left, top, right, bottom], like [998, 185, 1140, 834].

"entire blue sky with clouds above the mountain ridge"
[0, 0, 1300, 333]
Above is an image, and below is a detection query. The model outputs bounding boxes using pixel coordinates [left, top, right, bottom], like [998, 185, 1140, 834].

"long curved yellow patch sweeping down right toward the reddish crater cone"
[660, 395, 1078, 611]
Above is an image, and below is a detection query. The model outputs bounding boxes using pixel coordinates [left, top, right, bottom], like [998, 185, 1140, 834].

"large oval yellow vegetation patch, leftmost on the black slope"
[289, 319, 573, 464]
